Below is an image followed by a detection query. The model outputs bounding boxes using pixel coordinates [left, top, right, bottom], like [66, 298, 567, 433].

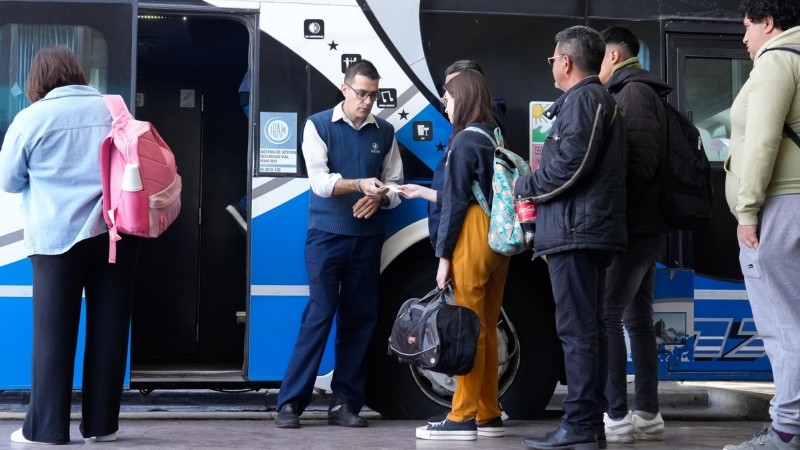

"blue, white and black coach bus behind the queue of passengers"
[0, 0, 771, 419]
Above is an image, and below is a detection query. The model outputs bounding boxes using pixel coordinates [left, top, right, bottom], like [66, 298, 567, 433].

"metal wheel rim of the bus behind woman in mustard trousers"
[408, 309, 521, 408]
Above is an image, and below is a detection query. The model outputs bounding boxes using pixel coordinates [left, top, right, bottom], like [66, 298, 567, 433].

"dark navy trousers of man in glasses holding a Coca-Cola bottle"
[547, 250, 612, 435]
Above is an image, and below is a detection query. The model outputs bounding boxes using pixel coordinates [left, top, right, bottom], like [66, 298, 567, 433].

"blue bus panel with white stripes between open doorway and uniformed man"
[248, 178, 335, 381]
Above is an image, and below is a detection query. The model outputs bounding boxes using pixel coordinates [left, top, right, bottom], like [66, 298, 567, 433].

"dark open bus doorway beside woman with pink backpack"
[131, 10, 250, 387]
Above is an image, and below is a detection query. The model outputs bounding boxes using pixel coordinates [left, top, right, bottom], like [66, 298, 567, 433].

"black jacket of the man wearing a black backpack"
[606, 67, 672, 236]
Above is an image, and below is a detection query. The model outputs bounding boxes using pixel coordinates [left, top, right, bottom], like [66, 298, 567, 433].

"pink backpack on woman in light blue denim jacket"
[100, 95, 181, 264]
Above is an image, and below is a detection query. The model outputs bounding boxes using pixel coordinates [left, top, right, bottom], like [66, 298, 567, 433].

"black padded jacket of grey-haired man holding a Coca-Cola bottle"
[514, 76, 628, 256]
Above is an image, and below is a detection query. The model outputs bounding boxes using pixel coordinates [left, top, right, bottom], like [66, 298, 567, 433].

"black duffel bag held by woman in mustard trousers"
[389, 283, 481, 375]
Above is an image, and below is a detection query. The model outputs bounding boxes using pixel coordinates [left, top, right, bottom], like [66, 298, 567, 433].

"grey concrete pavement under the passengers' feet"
[0, 414, 776, 450]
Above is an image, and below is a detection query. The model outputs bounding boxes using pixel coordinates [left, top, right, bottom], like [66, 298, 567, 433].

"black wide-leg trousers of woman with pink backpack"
[22, 234, 140, 444]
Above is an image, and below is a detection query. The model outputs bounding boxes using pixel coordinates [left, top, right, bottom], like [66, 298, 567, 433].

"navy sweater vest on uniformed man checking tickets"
[308, 109, 394, 236]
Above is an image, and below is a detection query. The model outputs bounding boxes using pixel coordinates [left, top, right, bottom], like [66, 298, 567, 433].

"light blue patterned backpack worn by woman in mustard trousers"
[465, 127, 531, 256]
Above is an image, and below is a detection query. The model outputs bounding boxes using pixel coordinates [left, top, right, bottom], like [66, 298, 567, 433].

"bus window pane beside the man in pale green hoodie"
[686, 57, 753, 162]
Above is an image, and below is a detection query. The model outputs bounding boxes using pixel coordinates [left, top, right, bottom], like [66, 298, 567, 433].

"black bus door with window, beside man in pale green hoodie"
[665, 29, 753, 280]
